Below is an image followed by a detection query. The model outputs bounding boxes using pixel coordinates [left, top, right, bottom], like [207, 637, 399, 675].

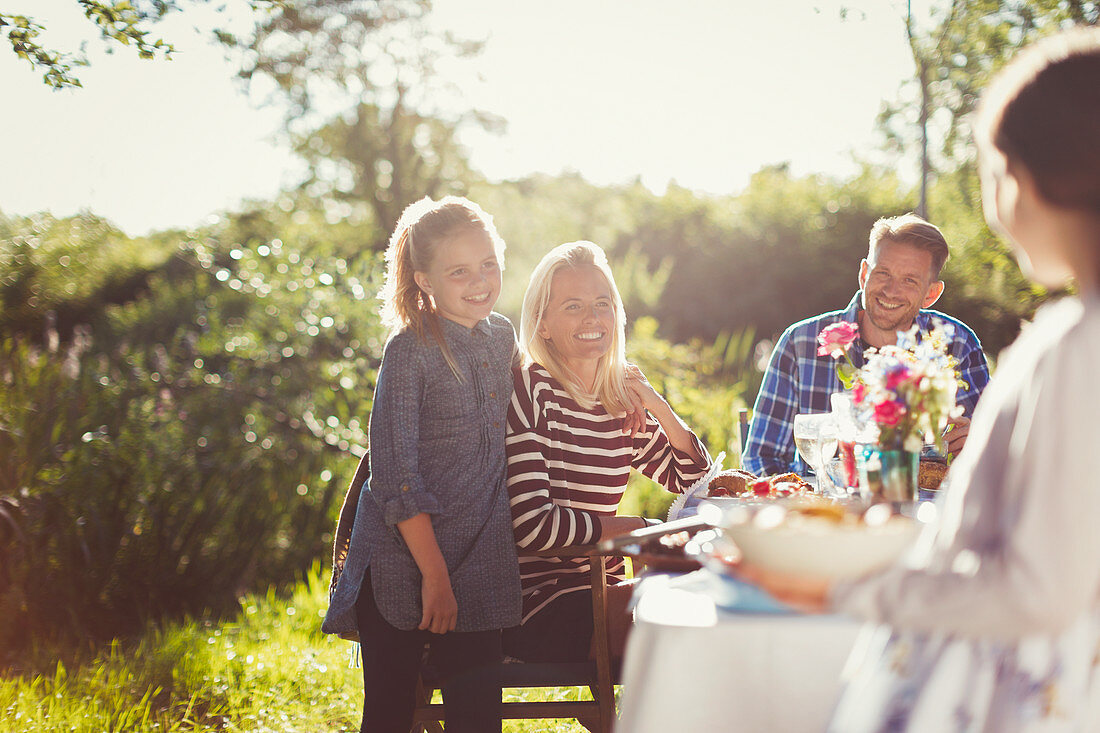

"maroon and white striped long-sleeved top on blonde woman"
[505, 364, 710, 622]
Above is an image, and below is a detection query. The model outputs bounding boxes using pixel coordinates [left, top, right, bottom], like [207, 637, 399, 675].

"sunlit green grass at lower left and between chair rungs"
[0, 567, 602, 733]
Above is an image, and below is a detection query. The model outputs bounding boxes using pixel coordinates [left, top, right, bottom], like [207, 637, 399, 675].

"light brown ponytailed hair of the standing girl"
[378, 196, 504, 379]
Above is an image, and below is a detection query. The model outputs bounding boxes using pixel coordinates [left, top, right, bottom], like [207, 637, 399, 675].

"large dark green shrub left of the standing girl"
[0, 211, 383, 656]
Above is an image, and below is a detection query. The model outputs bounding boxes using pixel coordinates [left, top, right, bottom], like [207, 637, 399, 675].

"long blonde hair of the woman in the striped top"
[519, 241, 628, 415]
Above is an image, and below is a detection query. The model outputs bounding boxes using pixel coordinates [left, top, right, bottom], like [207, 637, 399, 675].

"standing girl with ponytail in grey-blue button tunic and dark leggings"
[322, 197, 519, 733]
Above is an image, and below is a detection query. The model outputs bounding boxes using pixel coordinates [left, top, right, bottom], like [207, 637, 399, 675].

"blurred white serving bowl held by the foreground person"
[722, 499, 922, 580]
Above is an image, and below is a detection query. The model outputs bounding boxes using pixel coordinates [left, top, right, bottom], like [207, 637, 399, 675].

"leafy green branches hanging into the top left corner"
[0, 0, 283, 89]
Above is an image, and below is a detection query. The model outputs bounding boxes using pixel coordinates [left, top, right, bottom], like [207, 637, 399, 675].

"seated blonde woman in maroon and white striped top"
[505, 242, 710, 661]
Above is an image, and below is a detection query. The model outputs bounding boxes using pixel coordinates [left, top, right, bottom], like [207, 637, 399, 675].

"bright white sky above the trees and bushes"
[0, 0, 926, 234]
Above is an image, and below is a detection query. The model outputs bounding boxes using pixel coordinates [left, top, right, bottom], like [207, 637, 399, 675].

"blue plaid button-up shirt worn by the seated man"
[741, 292, 989, 475]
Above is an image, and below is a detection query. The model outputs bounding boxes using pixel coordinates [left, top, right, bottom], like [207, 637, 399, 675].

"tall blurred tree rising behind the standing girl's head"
[222, 0, 498, 248]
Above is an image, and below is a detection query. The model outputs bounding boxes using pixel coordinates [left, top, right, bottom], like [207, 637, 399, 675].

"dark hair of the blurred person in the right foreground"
[975, 28, 1100, 216]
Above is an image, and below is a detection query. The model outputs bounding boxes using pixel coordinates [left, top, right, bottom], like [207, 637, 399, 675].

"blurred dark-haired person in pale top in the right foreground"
[745, 30, 1100, 733]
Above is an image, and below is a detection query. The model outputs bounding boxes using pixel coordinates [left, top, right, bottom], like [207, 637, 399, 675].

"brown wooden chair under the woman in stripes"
[413, 546, 618, 733]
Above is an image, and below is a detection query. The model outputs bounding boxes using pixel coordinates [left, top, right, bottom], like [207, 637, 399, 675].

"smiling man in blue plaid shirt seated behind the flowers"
[743, 214, 989, 475]
